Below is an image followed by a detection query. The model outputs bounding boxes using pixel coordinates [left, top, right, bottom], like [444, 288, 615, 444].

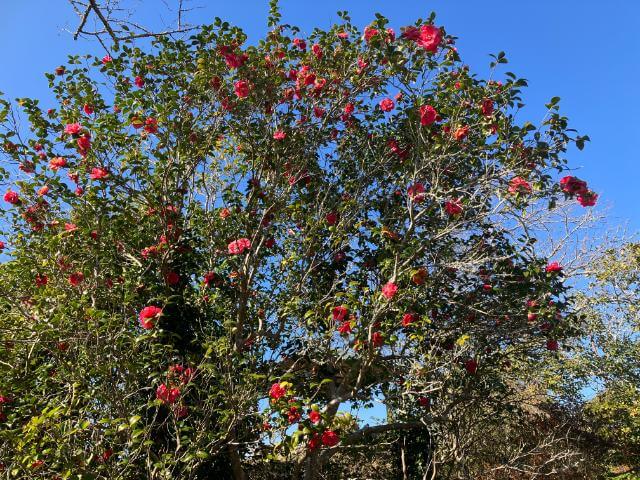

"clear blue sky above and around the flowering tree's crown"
[0, 0, 640, 231]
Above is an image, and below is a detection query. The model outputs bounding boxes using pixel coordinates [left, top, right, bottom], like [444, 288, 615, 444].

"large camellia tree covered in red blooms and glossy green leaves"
[0, 2, 597, 479]
